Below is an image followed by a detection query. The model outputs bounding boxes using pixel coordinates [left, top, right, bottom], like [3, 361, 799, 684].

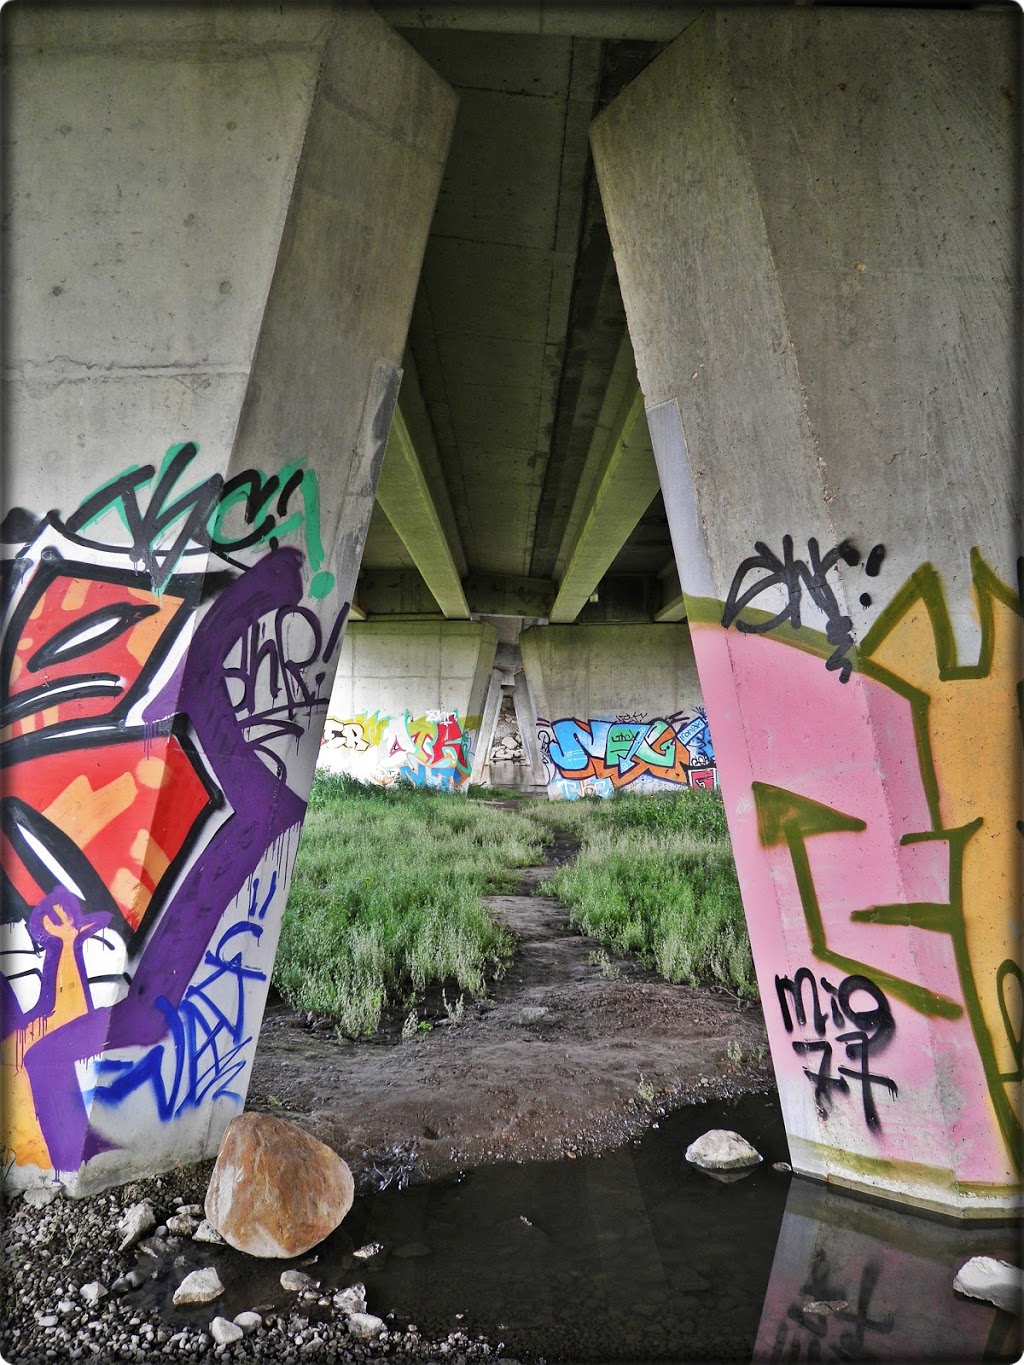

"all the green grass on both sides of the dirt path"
[273, 773, 756, 1036]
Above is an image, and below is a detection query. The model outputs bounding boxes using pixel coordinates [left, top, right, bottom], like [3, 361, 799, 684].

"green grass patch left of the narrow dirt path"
[273, 774, 542, 1036]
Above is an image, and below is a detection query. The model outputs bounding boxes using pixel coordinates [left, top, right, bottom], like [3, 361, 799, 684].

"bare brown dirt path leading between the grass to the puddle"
[247, 868, 771, 1178]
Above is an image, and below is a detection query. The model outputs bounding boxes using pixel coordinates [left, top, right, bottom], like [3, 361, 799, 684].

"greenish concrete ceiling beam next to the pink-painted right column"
[550, 337, 659, 624]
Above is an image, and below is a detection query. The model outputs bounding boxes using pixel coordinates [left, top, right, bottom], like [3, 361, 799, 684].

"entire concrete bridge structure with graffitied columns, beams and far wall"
[0, 3, 1024, 1216]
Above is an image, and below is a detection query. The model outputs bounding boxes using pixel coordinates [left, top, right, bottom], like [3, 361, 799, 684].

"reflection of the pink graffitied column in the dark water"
[754, 1179, 1021, 1365]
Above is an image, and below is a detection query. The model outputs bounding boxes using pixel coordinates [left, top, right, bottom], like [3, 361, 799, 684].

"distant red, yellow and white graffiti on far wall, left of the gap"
[319, 710, 479, 792]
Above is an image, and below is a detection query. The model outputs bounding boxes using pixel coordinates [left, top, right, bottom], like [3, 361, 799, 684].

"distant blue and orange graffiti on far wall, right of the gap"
[537, 707, 718, 800]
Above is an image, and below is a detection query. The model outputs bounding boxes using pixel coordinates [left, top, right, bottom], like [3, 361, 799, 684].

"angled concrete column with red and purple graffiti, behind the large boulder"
[0, 4, 453, 1193]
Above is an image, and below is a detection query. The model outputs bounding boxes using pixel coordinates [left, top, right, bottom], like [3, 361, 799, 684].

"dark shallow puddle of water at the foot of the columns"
[142, 1096, 1020, 1365]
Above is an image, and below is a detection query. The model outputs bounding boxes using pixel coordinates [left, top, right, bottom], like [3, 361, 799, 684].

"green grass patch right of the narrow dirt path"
[539, 792, 758, 999]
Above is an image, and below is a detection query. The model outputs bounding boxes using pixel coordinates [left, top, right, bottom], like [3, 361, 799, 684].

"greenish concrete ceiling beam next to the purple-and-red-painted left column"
[377, 407, 470, 620]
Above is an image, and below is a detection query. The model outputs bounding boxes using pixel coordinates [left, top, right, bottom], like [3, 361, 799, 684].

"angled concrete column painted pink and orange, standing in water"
[594, 8, 1021, 1216]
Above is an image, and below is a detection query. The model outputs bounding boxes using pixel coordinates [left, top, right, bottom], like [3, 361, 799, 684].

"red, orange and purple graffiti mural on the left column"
[0, 442, 348, 1175]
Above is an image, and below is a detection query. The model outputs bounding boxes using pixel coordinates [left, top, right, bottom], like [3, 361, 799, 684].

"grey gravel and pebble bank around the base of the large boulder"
[0, 1167, 516, 1365]
